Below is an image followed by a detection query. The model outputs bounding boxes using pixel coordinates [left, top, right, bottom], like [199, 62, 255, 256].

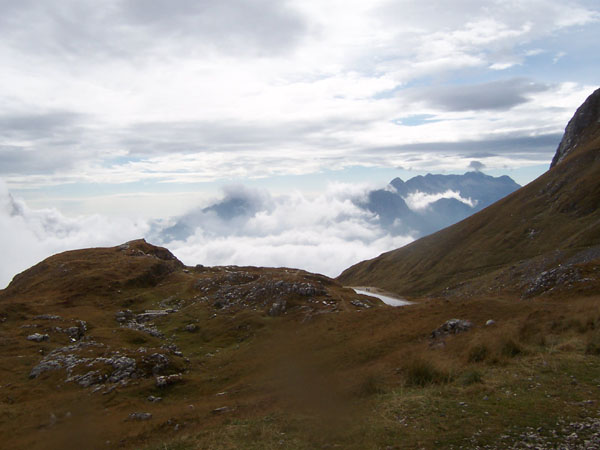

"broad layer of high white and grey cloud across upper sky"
[0, 0, 600, 192]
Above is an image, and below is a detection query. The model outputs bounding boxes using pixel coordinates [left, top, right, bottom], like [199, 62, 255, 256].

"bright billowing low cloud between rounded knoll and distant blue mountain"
[154, 185, 412, 276]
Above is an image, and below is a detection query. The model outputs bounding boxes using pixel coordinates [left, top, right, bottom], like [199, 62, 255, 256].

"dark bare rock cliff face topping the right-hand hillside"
[550, 89, 600, 168]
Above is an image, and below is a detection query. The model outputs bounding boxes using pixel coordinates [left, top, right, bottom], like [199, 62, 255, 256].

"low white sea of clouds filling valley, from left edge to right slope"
[0, 180, 413, 287]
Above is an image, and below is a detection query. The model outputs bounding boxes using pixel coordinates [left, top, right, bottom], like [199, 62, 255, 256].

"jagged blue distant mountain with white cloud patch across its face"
[359, 171, 520, 237]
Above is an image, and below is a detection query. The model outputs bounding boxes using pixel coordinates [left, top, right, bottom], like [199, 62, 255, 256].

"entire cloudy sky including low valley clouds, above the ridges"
[0, 0, 600, 286]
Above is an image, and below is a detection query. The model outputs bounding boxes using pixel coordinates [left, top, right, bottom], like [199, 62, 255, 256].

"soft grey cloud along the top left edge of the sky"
[0, 0, 306, 62]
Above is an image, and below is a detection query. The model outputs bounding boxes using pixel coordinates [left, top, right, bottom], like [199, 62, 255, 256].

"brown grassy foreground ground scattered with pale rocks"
[0, 242, 600, 450]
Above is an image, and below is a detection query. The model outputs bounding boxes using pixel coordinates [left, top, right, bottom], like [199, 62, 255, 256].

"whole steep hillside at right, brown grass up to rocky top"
[338, 90, 600, 296]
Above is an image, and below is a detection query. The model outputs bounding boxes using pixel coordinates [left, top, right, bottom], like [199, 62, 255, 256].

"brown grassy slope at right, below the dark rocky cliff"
[338, 133, 600, 296]
